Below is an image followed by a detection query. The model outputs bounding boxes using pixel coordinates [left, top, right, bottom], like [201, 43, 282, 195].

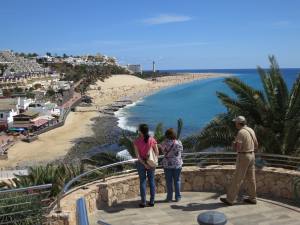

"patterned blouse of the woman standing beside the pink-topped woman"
[160, 139, 183, 169]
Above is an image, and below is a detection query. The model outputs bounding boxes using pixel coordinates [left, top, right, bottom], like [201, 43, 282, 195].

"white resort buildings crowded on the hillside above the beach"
[0, 51, 126, 159]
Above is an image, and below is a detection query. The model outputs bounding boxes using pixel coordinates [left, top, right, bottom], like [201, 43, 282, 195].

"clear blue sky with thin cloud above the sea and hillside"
[0, 0, 300, 70]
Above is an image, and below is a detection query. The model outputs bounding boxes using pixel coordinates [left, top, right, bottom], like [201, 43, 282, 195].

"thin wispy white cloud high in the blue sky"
[143, 14, 192, 25]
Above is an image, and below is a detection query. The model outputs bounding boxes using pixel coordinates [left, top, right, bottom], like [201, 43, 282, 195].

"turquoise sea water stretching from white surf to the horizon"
[116, 69, 300, 136]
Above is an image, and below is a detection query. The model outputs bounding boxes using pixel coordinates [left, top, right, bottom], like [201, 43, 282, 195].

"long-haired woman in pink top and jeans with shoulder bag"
[134, 124, 159, 208]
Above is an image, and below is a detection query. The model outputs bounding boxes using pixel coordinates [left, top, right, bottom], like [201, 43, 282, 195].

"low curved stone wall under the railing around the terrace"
[49, 166, 300, 225]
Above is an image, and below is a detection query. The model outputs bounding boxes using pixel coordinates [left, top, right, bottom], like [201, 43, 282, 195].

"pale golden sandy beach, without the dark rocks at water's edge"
[0, 74, 227, 168]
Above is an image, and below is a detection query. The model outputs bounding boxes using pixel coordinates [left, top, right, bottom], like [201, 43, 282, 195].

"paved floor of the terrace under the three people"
[90, 192, 300, 225]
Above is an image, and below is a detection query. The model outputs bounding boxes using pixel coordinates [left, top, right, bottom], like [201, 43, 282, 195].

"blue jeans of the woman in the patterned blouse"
[164, 168, 181, 201]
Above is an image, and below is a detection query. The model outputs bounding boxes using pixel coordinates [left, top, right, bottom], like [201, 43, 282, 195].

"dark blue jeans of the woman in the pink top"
[136, 162, 155, 204]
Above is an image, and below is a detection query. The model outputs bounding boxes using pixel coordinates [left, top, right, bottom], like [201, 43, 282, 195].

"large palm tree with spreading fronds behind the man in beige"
[195, 56, 300, 155]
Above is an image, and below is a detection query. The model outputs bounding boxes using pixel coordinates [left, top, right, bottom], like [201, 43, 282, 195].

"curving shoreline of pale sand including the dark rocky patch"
[0, 73, 229, 168]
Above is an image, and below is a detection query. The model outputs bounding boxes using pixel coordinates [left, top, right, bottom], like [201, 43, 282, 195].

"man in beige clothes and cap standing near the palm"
[220, 116, 258, 205]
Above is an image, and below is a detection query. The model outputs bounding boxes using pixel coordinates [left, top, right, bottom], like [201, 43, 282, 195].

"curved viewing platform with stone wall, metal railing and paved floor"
[48, 152, 300, 225]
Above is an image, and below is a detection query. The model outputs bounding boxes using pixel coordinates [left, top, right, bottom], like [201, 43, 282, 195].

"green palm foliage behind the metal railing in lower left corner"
[0, 163, 84, 225]
